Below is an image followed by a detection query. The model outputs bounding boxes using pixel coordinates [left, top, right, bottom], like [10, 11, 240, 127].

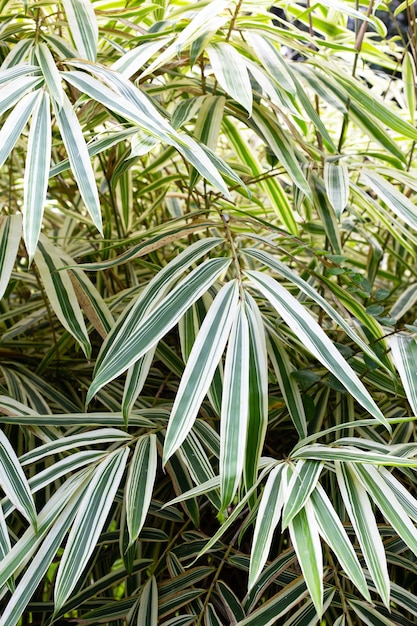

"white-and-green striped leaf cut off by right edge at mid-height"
[388, 333, 417, 415]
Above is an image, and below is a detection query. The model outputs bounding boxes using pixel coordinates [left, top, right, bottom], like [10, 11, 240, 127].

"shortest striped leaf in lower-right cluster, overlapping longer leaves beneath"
[282, 461, 323, 529]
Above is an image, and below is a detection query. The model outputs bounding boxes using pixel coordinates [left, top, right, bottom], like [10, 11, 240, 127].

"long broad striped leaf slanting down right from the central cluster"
[245, 271, 390, 428]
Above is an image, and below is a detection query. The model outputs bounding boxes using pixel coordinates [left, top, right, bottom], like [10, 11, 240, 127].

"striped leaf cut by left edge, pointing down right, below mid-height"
[0, 430, 38, 528]
